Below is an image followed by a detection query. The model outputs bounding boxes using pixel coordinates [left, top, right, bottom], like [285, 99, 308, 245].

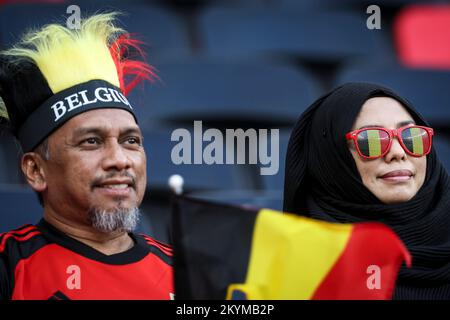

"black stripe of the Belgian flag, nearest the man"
[172, 196, 258, 300]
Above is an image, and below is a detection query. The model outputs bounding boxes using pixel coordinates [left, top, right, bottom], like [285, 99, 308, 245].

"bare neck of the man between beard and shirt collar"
[44, 212, 134, 255]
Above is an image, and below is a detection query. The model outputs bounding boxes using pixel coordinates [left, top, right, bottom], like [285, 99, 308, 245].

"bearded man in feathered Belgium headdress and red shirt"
[0, 13, 173, 299]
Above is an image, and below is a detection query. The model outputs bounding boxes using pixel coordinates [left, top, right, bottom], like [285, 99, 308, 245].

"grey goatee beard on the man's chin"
[89, 207, 140, 233]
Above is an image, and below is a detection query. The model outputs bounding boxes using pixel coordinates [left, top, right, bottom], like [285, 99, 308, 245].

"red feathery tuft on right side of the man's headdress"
[109, 34, 159, 95]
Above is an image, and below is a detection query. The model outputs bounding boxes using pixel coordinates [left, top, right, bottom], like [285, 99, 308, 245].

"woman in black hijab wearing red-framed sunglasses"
[284, 83, 450, 299]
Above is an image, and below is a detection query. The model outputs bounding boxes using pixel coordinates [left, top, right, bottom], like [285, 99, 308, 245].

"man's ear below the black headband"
[21, 152, 47, 192]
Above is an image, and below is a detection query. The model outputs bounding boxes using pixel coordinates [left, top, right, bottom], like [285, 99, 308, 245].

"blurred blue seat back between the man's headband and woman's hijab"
[130, 61, 321, 127]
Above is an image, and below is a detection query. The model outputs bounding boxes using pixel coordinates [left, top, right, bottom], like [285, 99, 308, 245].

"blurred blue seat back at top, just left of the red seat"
[199, 8, 394, 62]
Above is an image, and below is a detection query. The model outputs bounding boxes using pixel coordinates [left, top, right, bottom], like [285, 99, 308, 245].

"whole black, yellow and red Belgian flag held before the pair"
[172, 197, 411, 300]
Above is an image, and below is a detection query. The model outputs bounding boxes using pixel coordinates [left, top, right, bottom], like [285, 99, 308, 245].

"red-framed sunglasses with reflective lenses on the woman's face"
[345, 125, 434, 159]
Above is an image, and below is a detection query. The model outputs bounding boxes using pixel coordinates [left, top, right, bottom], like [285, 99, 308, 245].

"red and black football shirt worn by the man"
[0, 219, 174, 300]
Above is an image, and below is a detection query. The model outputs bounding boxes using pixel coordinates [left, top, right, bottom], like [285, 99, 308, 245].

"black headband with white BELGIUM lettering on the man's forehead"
[18, 80, 137, 152]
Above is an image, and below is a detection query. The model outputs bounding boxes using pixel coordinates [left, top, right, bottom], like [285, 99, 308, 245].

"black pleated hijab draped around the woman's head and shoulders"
[284, 83, 450, 299]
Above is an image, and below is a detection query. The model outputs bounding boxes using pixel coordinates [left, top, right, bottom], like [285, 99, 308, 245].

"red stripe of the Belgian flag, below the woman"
[312, 223, 411, 300]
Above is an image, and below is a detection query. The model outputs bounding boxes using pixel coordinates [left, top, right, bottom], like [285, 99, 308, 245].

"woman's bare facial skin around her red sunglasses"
[349, 97, 427, 204]
